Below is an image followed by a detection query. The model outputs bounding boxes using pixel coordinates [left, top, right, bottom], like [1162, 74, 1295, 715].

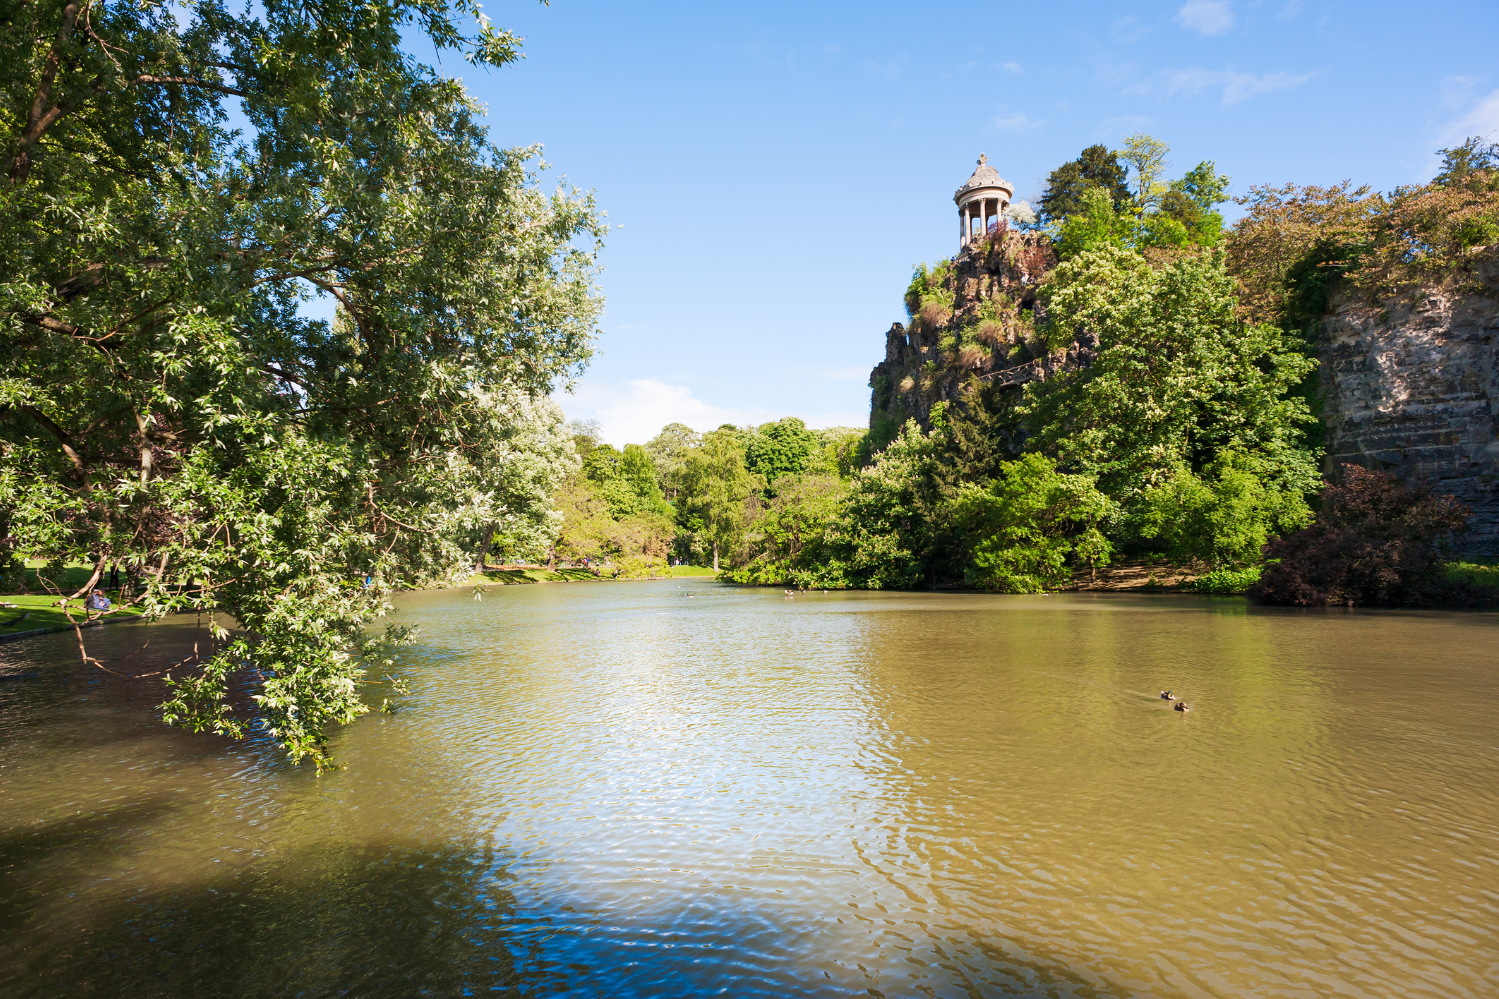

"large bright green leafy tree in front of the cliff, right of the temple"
[1024, 246, 1319, 506]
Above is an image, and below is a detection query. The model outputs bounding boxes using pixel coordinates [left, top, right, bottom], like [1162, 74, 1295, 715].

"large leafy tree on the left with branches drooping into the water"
[0, 0, 606, 765]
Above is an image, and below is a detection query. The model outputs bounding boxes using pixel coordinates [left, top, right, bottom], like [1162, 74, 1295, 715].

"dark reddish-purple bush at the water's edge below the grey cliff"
[1250, 465, 1472, 606]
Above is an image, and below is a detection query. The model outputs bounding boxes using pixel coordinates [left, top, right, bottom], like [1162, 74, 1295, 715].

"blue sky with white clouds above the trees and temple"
[445, 0, 1499, 444]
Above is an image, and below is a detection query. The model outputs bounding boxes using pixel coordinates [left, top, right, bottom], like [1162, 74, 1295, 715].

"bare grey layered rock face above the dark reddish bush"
[1319, 251, 1499, 557]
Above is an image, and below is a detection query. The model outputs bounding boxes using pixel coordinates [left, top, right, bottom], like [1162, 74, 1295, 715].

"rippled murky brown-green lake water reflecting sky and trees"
[0, 582, 1499, 999]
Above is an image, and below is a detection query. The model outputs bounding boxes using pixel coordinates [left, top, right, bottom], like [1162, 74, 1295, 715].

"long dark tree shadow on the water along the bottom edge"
[0, 816, 1133, 999]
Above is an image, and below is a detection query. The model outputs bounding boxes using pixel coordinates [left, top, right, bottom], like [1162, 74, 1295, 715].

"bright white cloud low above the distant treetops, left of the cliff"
[558, 378, 869, 447]
